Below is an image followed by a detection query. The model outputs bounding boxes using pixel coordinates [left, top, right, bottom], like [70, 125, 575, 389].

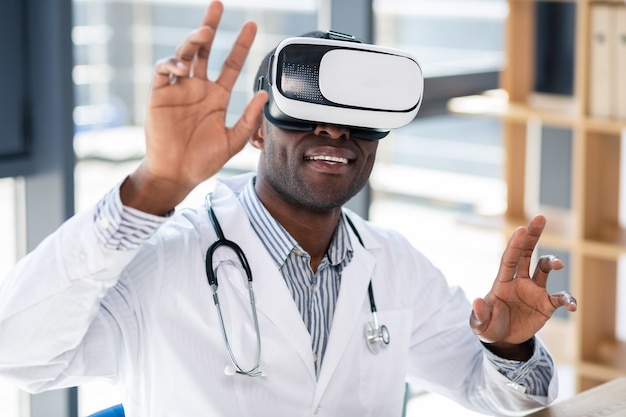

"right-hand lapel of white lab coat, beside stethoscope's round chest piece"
[316, 233, 376, 401]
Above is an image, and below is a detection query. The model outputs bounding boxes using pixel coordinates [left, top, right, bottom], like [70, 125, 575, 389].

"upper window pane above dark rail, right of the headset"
[374, 0, 508, 77]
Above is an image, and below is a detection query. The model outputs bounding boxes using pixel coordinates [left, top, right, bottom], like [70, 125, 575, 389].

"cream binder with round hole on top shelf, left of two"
[589, 3, 615, 118]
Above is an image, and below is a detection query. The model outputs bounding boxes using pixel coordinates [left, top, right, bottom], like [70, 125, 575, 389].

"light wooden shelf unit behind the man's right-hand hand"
[448, 0, 626, 391]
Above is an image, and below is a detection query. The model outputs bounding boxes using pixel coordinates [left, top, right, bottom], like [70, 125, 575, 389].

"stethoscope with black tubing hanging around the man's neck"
[205, 195, 389, 376]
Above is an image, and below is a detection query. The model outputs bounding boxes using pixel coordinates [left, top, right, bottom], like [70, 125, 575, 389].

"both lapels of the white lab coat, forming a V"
[211, 174, 378, 390]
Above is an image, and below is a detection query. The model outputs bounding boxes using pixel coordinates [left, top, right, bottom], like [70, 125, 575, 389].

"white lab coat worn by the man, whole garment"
[0, 176, 556, 417]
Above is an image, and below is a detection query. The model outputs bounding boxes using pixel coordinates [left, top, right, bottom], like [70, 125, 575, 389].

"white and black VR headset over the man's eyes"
[256, 32, 424, 140]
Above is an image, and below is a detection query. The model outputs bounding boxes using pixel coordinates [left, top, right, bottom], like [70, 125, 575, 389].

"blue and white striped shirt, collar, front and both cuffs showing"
[94, 179, 554, 395]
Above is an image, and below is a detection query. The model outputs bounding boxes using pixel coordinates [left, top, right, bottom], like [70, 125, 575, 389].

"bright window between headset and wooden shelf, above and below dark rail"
[370, 0, 508, 282]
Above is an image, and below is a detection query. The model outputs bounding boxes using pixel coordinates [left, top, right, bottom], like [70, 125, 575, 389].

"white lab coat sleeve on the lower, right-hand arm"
[394, 231, 556, 415]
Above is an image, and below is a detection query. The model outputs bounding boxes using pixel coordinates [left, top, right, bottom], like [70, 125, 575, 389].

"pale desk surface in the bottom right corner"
[527, 377, 626, 417]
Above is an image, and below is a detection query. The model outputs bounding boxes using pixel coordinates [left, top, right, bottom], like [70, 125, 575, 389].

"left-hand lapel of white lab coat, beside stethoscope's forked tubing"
[212, 180, 315, 379]
